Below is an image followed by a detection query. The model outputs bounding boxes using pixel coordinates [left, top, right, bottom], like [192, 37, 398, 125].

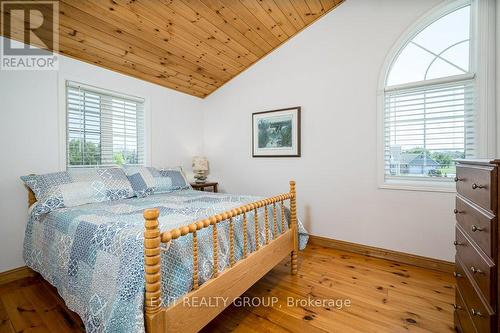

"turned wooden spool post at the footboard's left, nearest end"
[144, 208, 161, 324]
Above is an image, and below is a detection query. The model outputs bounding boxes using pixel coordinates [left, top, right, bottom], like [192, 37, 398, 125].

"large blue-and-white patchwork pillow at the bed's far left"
[21, 168, 134, 216]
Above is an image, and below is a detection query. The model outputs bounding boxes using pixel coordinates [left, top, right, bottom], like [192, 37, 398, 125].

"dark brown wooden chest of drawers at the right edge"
[454, 160, 500, 333]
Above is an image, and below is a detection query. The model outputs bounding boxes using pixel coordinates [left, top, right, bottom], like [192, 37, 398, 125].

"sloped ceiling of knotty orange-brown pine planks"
[1, 0, 343, 98]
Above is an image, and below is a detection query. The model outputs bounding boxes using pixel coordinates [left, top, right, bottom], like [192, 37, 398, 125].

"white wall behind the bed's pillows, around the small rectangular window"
[0, 39, 202, 272]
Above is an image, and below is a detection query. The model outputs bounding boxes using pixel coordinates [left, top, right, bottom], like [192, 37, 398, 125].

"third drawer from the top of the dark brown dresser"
[455, 226, 496, 306]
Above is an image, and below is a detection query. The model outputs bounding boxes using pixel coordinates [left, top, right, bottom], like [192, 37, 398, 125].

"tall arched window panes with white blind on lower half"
[383, 1, 477, 188]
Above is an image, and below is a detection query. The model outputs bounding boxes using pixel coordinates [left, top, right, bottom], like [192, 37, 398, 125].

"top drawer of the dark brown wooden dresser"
[456, 165, 497, 213]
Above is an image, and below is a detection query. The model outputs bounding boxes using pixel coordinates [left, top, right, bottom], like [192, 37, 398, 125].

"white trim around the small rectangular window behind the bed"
[57, 73, 152, 170]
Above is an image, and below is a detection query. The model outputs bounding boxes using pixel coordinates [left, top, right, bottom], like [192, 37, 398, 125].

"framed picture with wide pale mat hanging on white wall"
[252, 106, 300, 157]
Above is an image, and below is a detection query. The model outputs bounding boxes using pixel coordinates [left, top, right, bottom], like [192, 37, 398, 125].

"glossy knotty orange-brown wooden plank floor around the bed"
[0, 245, 455, 333]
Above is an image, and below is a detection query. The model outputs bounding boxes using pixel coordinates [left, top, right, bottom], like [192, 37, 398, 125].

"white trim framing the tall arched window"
[377, 0, 497, 192]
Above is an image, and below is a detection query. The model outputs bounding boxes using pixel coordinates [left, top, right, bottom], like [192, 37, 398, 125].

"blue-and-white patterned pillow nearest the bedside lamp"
[125, 166, 190, 198]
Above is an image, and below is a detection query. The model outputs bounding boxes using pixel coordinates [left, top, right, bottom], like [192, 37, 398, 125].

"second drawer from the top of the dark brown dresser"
[455, 196, 496, 257]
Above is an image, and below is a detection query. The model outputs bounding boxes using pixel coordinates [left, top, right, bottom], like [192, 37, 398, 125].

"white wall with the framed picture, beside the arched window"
[204, 0, 454, 260]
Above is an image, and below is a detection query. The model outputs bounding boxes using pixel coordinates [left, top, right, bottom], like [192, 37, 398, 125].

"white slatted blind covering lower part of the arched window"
[384, 79, 476, 180]
